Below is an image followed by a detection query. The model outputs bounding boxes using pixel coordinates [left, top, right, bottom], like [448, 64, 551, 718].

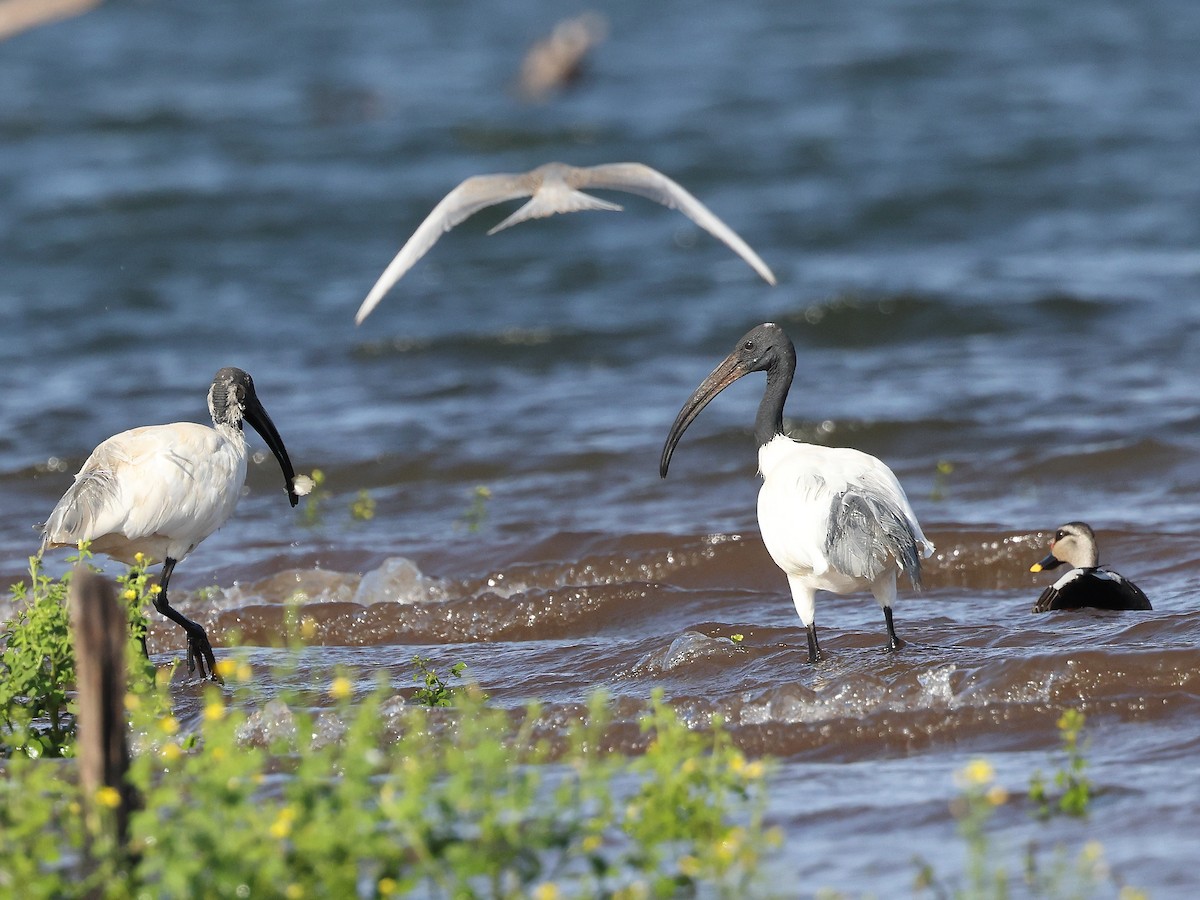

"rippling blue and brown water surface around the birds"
[0, 0, 1200, 896]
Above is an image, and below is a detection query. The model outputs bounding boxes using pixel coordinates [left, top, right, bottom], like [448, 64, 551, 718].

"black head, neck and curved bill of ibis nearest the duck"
[659, 322, 796, 478]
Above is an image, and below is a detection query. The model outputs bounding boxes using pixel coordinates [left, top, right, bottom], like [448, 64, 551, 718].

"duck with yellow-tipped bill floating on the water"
[1030, 522, 1151, 612]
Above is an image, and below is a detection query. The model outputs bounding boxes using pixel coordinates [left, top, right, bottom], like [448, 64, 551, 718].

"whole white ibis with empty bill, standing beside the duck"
[659, 323, 934, 662]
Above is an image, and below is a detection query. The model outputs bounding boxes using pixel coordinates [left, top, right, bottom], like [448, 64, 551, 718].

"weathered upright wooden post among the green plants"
[70, 566, 133, 852]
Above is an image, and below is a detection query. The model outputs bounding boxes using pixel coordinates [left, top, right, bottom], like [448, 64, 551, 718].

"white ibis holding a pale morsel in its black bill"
[38, 367, 312, 678]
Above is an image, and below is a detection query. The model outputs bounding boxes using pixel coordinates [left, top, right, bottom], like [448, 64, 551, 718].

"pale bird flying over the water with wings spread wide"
[354, 162, 775, 324]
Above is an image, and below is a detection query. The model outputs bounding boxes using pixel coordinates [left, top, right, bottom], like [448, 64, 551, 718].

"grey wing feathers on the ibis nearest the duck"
[826, 487, 920, 589]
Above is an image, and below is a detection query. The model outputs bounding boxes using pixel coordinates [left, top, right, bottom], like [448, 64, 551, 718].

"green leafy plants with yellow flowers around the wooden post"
[0, 562, 778, 900]
